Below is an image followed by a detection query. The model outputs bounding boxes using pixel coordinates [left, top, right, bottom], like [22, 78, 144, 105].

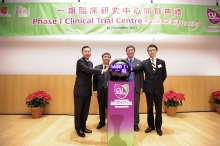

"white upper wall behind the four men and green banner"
[0, 0, 220, 76]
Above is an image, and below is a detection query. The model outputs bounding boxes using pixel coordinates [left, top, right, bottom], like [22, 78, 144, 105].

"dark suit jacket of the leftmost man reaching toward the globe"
[74, 57, 102, 97]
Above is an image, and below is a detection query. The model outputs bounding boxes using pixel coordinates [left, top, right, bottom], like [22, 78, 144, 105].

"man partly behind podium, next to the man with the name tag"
[126, 45, 143, 131]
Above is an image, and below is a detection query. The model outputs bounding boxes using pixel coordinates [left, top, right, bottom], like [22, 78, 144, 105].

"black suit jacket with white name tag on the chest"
[132, 58, 167, 94]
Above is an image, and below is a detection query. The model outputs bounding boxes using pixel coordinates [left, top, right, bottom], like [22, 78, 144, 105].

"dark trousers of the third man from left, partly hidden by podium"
[134, 89, 140, 125]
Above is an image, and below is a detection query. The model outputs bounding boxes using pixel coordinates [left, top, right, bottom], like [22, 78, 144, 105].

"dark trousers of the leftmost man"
[74, 95, 91, 130]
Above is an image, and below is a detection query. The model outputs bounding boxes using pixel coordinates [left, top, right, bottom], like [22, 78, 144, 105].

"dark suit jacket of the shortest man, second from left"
[93, 64, 110, 96]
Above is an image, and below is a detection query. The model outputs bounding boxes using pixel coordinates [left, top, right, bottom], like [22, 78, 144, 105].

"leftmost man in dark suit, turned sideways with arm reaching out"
[73, 46, 108, 137]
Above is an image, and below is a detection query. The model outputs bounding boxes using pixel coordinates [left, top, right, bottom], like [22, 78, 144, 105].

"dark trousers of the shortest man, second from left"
[98, 87, 108, 124]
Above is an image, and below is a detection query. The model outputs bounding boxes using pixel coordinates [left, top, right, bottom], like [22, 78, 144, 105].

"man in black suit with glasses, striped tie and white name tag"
[132, 44, 167, 136]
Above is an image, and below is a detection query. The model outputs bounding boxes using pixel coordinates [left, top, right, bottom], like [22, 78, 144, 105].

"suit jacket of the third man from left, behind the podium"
[126, 58, 144, 94]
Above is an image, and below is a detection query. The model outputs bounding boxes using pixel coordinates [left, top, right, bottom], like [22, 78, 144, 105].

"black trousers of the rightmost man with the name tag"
[145, 93, 163, 128]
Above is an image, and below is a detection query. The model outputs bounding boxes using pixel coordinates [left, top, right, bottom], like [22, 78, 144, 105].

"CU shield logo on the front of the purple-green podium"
[114, 84, 129, 99]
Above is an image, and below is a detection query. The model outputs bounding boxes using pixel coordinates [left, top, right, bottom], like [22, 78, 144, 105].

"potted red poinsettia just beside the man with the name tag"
[163, 90, 185, 116]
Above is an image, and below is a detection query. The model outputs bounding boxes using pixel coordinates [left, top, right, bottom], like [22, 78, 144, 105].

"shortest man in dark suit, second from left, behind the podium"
[93, 53, 111, 129]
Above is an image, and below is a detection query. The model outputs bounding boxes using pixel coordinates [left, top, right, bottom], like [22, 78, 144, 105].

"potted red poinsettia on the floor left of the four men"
[25, 91, 52, 119]
